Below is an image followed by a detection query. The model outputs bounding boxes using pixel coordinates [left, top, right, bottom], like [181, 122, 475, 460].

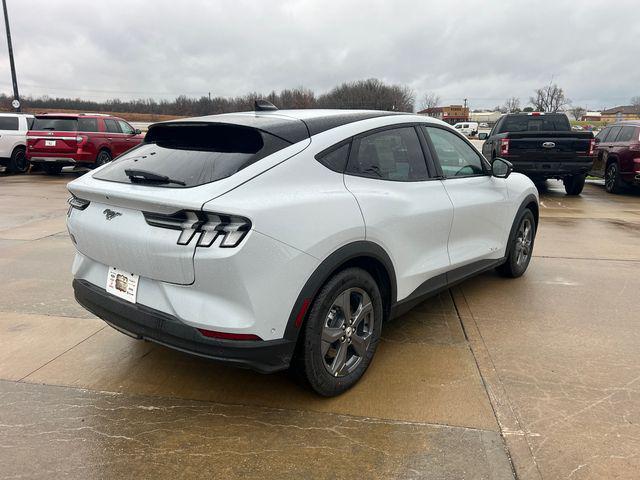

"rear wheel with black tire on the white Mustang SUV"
[292, 268, 384, 397]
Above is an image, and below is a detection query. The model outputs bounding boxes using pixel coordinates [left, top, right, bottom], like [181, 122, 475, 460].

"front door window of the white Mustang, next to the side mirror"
[423, 127, 485, 178]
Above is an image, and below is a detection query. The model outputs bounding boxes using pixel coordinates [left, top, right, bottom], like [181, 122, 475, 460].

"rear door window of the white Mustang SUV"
[347, 127, 427, 182]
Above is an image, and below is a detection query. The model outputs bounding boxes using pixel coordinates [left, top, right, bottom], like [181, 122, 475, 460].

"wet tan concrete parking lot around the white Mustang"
[0, 173, 640, 479]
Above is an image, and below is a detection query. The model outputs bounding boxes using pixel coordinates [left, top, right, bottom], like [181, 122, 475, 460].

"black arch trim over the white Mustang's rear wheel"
[284, 240, 397, 341]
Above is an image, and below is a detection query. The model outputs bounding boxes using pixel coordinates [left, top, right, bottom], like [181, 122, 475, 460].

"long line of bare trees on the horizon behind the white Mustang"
[0, 78, 415, 116]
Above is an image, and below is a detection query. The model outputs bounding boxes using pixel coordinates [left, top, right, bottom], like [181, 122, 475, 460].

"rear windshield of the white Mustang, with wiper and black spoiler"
[94, 123, 290, 188]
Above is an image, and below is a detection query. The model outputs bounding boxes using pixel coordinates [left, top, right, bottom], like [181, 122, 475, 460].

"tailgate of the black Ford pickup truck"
[507, 131, 593, 161]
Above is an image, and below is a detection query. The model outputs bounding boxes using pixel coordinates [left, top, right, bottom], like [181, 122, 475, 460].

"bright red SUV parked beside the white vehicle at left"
[27, 113, 144, 175]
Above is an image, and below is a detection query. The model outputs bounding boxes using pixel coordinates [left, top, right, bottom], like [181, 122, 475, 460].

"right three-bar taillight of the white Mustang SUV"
[144, 210, 251, 248]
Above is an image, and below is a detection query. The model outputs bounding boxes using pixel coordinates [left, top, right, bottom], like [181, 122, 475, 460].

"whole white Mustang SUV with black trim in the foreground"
[67, 106, 538, 396]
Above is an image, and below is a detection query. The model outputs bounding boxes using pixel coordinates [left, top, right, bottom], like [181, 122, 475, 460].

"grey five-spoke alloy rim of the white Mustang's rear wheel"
[321, 288, 375, 377]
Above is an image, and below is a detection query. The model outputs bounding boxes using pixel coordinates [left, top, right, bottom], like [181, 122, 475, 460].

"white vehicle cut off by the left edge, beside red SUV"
[0, 113, 33, 173]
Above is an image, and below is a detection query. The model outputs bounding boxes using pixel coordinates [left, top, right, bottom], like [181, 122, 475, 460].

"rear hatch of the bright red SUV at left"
[27, 115, 78, 158]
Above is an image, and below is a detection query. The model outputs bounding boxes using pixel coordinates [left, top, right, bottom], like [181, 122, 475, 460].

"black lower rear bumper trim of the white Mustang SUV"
[73, 280, 295, 373]
